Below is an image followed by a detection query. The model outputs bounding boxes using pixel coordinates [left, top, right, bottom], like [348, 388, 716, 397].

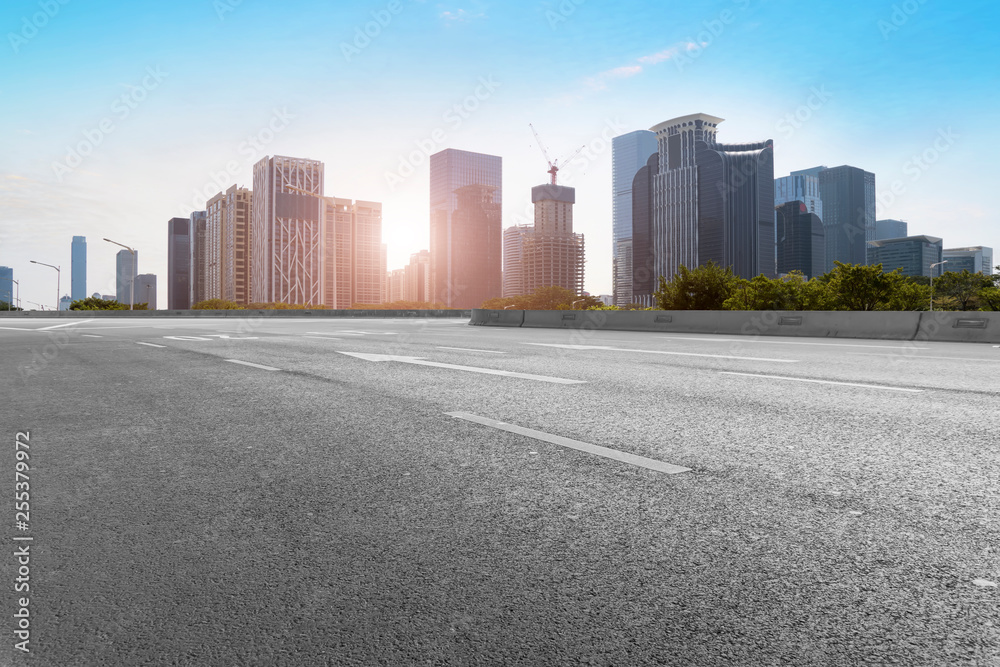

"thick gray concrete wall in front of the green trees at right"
[469, 309, 1000, 344]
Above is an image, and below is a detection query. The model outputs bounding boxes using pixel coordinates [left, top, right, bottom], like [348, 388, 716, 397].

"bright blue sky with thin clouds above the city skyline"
[0, 0, 1000, 307]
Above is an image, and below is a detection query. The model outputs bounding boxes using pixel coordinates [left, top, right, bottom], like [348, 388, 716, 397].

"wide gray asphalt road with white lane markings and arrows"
[0, 318, 1000, 667]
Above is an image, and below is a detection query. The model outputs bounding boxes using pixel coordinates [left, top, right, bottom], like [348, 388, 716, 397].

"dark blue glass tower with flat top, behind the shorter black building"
[818, 165, 875, 271]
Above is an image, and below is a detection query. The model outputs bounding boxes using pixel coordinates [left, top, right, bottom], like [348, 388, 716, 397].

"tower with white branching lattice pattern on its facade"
[250, 155, 324, 305]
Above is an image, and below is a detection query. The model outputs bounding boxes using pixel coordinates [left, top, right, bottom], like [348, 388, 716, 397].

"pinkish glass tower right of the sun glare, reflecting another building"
[430, 148, 503, 308]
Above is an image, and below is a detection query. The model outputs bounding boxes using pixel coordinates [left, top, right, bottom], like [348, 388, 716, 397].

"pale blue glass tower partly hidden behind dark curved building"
[612, 130, 657, 306]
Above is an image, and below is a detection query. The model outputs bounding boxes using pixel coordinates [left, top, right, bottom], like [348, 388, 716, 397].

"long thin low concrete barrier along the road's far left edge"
[0, 308, 472, 319]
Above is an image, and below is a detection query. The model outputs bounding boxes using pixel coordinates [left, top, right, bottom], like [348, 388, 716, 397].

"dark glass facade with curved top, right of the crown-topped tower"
[695, 141, 775, 279]
